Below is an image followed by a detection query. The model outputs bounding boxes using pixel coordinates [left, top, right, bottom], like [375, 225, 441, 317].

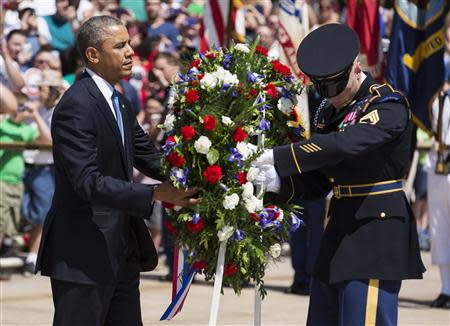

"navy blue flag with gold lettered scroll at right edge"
[386, 0, 450, 131]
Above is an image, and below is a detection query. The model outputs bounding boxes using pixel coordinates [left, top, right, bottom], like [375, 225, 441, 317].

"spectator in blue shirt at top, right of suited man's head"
[145, 0, 180, 51]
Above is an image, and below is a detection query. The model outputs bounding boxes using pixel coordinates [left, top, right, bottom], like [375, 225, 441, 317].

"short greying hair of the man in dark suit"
[77, 16, 123, 61]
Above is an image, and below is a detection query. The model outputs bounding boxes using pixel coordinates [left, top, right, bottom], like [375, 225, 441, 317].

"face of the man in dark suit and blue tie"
[93, 25, 134, 84]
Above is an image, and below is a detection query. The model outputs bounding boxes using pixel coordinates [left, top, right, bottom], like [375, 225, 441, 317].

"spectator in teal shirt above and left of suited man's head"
[44, 0, 80, 52]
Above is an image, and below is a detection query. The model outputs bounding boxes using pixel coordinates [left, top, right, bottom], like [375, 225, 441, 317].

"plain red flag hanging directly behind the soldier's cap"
[346, 0, 384, 82]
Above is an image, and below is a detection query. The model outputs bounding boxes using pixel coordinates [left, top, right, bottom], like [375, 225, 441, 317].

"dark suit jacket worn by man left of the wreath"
[36, 73, 161, 284]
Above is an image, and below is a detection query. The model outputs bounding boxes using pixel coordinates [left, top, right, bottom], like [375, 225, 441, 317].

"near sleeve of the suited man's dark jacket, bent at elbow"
[51, 99, 153, 216]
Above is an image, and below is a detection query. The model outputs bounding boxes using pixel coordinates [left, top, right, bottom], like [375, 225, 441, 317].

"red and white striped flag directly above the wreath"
[200, 0, 245, 52]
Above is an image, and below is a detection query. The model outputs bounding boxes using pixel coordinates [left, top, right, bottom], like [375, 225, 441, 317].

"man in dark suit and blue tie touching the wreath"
[36, 16, 197, 326]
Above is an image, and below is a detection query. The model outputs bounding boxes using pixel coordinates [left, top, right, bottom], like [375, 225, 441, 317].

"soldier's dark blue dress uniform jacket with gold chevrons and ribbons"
[274, 76, 425, 284]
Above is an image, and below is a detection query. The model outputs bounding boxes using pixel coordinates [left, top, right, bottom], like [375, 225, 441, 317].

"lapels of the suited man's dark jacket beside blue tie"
[82, 73, 129, 177]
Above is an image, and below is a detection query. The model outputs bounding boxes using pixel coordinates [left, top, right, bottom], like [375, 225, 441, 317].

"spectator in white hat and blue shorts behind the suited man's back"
[21, 69, 64, 276]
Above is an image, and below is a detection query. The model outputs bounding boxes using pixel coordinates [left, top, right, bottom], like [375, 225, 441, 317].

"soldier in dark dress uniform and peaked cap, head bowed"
[254, 24, 425, 326]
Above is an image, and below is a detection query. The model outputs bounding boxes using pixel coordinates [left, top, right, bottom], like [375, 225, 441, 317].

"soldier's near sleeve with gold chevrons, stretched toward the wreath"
[274, 103, 410, 178]
